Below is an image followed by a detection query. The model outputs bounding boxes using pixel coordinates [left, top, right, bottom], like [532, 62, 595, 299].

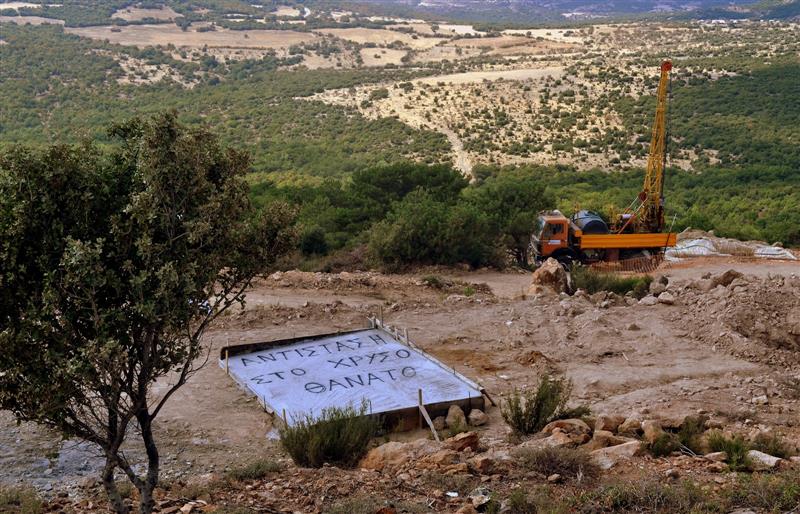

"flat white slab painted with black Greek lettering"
[220, 326, 484, 425]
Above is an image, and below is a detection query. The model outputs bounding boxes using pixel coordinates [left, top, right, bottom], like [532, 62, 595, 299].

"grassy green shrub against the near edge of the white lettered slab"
[280, 401, 379, 468]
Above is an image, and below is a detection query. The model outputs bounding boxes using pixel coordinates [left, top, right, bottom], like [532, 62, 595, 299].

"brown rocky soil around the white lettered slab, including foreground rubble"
[0, 260, 800, 512]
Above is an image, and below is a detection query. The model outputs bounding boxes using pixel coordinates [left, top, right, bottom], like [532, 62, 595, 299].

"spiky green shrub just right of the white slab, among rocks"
[501, 374, 588, 434]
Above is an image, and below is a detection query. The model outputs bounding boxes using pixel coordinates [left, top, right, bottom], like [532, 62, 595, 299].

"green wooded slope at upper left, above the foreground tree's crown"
[0, 24, 449, 183]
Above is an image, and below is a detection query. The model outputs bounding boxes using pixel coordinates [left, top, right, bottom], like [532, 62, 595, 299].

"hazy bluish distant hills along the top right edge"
[349, 0, 800, 25]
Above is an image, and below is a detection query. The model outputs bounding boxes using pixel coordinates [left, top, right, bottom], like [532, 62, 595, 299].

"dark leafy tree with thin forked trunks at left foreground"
[0, 113, 295, 513]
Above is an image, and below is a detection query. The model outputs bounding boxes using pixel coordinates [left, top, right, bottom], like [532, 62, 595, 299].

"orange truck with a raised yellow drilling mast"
[530, 61, 676, 269]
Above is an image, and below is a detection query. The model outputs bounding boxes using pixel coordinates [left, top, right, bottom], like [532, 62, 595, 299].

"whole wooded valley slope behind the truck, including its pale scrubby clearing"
[0, 15, 800, 268]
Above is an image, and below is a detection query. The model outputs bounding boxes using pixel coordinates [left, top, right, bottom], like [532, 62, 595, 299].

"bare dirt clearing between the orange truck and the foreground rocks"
[0, 258, 800, 508]
